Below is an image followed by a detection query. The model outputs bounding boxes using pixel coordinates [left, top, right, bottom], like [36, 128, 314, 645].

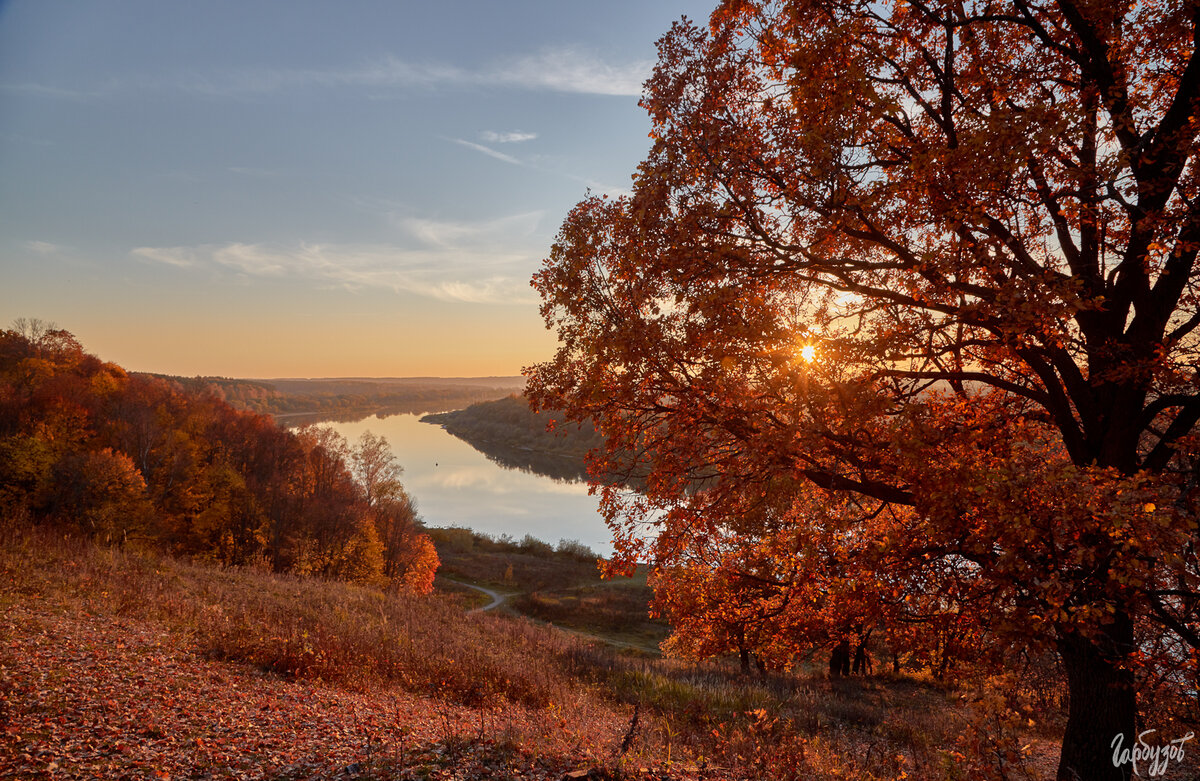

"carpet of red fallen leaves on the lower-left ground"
[0, 606, 624, 780]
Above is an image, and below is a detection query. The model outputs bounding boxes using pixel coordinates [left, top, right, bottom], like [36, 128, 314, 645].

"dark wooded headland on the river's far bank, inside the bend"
[421, 393, 604, 480]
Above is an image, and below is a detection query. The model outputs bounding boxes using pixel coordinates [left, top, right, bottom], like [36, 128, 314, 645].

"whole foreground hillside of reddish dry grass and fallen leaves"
[0, 528, 1070, 780]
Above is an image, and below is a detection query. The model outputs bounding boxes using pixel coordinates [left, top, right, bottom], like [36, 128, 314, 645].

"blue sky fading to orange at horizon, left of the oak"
[0, 0, 714, 378]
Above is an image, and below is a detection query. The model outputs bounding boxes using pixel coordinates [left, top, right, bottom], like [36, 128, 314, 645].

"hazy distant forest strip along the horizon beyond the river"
[155, 374, 524, 425]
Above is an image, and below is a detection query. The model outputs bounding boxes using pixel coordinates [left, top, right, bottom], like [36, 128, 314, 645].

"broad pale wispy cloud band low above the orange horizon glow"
[132, 212, 540, 305]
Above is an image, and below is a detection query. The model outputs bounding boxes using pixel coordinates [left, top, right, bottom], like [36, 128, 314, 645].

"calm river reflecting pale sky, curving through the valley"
[322, 415, 612, 555]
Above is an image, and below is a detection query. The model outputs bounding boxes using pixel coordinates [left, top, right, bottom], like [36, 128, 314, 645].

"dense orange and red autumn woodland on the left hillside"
[0, 322, 438, 593]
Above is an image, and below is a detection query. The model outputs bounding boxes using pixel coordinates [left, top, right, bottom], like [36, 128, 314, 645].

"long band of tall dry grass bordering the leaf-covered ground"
[0, 528, 1070, 781]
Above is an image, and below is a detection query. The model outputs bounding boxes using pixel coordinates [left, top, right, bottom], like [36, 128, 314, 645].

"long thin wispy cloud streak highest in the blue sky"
[0, 47, 653, 101]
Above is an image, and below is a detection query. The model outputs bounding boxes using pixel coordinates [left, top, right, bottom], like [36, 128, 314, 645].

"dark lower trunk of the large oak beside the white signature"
[1057, 613, 1138, 781]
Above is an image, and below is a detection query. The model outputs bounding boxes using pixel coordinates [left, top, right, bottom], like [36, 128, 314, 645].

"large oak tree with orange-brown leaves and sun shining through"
[530, 0, 1200, 780]
